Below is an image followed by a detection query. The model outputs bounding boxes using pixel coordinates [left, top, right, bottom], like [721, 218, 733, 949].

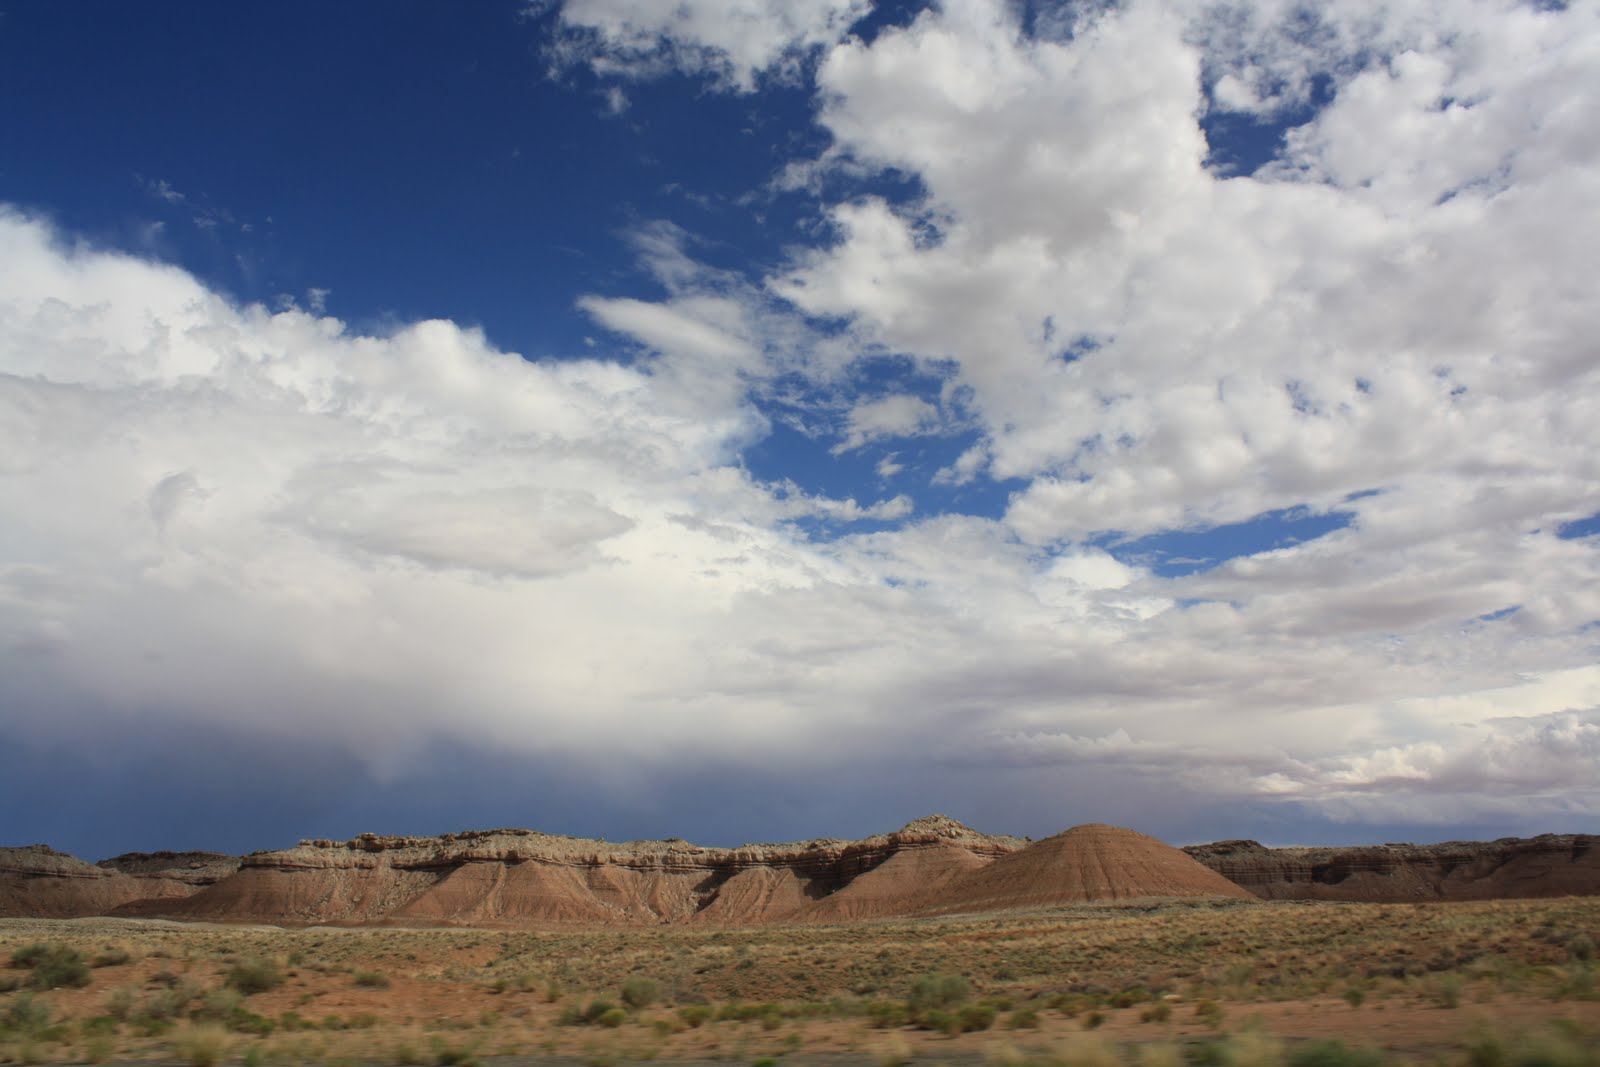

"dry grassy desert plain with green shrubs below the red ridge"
[0, 897, 1600, 1067]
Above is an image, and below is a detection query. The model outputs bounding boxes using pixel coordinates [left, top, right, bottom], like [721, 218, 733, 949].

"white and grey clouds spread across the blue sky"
[0, 0, 1600, 835]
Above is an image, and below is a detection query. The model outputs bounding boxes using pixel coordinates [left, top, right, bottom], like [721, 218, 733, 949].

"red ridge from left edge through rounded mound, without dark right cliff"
[0, 816, 1248, 926]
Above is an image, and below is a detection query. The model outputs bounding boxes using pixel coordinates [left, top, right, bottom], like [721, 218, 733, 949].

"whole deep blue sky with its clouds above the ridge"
[0, 0, 1600, 859]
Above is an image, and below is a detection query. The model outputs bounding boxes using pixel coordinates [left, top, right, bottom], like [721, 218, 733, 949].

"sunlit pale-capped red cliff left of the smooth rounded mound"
[166, 816, 1027, 925]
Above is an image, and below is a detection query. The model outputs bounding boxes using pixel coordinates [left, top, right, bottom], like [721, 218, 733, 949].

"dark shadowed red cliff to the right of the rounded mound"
[1184, 833, 1600, 901]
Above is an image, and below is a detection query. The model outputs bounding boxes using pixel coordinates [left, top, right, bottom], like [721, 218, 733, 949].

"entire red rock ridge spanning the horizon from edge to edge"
[0, 816, 1600, 928]
